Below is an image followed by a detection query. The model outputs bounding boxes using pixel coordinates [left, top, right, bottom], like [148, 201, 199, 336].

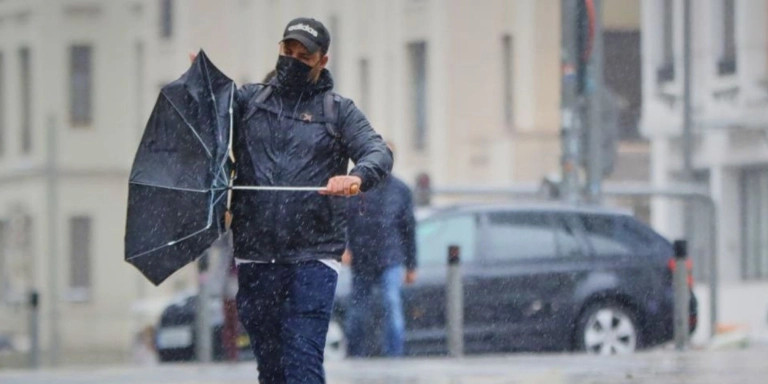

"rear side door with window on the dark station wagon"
[473, 211, 589, 350]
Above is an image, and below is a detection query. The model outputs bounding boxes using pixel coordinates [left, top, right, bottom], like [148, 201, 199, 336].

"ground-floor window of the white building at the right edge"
[741, 169, 768, 280]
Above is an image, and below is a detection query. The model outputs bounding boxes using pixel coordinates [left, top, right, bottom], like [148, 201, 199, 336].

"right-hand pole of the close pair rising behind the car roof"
[587, 0, 605, 204]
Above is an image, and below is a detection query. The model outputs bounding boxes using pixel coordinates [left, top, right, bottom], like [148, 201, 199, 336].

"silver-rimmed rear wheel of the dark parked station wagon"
[576, 302, 640, 355]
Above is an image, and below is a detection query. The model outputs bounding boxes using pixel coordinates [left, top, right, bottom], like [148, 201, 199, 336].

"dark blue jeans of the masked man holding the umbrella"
[237, 261, 338, 384]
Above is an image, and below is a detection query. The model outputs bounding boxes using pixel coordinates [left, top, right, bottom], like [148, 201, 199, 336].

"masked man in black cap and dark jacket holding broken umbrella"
[195, 18, 392, 384]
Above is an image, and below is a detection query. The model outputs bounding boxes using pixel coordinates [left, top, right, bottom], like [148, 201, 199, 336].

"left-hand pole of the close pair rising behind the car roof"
[560, 0, 582, 204]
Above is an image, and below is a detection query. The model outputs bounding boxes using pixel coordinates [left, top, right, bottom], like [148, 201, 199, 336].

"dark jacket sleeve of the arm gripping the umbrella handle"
[339, 98, 392, 192]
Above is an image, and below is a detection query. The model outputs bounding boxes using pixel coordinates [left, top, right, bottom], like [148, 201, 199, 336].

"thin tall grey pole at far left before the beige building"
[46, 115, 61, 366]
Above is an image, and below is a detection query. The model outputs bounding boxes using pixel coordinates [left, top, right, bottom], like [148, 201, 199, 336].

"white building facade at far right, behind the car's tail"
[641, 0, 768, 340]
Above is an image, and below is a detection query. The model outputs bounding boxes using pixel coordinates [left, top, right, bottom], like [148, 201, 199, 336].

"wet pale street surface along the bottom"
[0, 348, 768, 384]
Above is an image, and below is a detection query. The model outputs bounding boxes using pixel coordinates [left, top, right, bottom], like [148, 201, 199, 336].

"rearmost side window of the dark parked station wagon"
[580, 215, 646, 256]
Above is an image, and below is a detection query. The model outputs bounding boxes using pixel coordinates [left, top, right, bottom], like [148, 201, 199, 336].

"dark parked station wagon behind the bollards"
[334, 205, 697, 355]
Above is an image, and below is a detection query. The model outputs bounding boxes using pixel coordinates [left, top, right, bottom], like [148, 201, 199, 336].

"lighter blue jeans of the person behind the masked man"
[346, 265, 405, 357]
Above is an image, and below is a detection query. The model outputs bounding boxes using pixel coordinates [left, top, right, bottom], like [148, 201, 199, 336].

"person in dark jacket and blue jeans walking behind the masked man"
[344, 160, 416, 357]
